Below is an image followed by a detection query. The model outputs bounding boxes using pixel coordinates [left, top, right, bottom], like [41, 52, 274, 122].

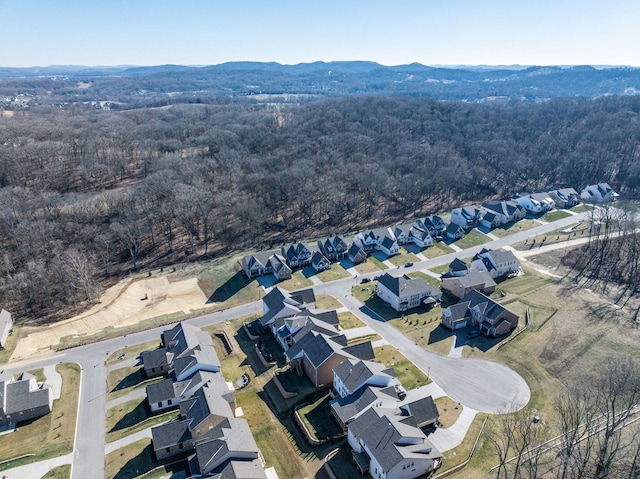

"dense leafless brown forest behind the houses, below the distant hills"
[0, 96, 640, 318]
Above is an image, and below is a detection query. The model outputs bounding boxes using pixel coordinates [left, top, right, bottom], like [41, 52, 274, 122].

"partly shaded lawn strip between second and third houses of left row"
[106, 399, 180, 442]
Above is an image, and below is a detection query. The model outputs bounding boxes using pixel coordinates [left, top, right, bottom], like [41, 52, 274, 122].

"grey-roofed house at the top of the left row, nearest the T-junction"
[140, 322, 220, 381]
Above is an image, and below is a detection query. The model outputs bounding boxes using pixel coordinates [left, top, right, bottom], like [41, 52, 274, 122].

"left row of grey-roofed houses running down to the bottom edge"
[141, 323, 267, 479]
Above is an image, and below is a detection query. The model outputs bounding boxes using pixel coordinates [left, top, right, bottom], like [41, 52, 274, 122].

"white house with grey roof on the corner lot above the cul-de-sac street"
[376, 273, 441, 311]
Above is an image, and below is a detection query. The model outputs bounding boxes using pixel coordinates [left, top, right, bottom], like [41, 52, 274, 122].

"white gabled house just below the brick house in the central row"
[333, 358, 400, 398]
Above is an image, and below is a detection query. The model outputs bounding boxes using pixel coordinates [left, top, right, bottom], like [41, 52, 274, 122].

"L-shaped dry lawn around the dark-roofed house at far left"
[0, 363, 80, 470]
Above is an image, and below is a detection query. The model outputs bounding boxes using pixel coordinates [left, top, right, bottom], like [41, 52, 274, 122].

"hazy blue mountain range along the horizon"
[0, 61, 640, 102]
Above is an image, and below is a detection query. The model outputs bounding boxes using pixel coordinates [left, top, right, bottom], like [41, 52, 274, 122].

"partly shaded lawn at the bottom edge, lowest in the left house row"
[104, 439, 186, 479]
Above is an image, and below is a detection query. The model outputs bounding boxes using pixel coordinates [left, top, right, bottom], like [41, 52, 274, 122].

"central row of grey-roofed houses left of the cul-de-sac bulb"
[260, 287, 442, 479]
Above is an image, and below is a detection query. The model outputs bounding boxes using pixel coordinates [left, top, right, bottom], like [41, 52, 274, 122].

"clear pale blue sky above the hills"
[0, 0, 640, 67]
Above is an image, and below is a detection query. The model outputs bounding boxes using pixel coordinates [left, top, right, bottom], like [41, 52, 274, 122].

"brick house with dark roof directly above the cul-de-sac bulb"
[442, 290, 519, 337]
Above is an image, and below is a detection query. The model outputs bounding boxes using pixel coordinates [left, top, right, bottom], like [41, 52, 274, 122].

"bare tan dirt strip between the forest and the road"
[10, 276, 207, 361]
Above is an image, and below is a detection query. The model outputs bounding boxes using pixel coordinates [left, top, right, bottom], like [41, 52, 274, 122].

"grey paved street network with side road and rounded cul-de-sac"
[5, 213, 586, 479]
